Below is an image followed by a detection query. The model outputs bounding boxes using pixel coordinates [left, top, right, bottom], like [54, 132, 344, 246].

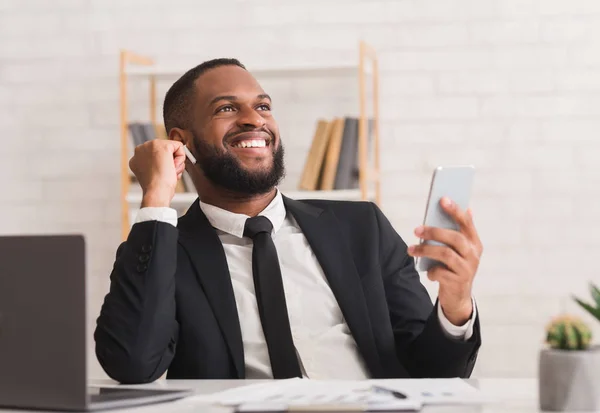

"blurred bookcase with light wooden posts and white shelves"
[119, 42, 381, 239]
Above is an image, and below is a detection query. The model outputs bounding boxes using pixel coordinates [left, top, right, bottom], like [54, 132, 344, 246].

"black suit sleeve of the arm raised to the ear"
[94, 221, 179, 384]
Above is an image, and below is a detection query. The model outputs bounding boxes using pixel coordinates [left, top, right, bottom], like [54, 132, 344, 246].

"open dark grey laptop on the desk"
[0, 235, 192, 411]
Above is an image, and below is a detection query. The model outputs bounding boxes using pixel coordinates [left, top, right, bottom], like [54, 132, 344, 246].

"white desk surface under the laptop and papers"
[0, 379, 568, 413]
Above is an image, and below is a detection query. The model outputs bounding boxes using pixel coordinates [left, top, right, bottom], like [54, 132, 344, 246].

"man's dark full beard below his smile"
[193, 135, 285, 196]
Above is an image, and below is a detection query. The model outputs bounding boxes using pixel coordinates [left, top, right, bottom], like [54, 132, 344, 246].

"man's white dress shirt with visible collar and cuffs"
[136, 191, 476, 379]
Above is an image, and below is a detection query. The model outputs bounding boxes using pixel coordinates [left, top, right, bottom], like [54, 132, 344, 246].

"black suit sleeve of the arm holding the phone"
[373, 204, 481, 378]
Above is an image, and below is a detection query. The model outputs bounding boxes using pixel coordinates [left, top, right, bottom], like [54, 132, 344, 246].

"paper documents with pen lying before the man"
[194, 378, 485, 412]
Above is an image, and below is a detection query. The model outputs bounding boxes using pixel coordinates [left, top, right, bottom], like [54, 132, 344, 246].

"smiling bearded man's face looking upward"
[192, 66, 284, 195]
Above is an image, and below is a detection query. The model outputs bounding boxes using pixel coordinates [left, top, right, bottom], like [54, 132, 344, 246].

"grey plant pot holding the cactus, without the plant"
[539, 347, 600, 412]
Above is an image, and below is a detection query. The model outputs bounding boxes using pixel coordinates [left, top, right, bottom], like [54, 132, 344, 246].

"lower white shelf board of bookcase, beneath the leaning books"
[127, 189, 375, 208]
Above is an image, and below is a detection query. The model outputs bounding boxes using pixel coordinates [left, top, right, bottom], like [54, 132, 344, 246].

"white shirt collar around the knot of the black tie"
[200, 190, 286, 238]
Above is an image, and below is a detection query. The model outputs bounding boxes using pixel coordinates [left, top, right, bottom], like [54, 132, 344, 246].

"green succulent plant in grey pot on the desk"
[538, 284, 600, 411]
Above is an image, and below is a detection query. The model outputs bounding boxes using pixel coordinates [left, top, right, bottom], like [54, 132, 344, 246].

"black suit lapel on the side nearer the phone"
[284, 197, 382, 377]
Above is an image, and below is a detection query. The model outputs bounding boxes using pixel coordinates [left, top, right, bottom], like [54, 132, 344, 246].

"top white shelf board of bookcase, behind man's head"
[125, 63, 370, 77]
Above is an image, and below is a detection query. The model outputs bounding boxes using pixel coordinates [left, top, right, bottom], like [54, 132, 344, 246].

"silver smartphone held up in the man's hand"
[417, 165, 475, 271]
